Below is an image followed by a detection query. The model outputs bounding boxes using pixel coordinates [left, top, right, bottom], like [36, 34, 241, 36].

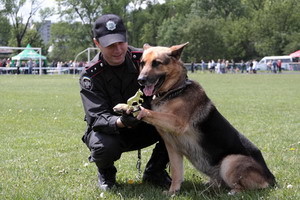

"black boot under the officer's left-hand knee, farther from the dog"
[98, 166, 117, 191]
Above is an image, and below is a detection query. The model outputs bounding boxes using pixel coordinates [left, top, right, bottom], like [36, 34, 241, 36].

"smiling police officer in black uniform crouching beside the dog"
[80, 14, 171, 190]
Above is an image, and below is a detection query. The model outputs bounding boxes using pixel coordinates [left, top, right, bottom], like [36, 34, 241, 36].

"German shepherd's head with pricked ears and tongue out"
[138, 43, 188, 96]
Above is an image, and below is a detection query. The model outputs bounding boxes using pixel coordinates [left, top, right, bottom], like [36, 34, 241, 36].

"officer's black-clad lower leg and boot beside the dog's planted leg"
[143, 142, 172, 188]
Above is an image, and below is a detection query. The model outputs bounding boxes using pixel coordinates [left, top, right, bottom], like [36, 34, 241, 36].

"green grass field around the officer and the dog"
[0, 73, 300, 200]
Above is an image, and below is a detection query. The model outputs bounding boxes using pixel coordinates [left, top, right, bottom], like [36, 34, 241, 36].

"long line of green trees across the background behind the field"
[0, 0, 300, 62]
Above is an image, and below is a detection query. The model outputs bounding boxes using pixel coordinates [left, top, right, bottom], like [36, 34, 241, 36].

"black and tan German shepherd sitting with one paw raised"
[118, 43, 276, 194]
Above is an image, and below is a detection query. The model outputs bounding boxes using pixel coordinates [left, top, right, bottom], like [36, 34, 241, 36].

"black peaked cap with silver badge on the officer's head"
[93, 14, 127, 47]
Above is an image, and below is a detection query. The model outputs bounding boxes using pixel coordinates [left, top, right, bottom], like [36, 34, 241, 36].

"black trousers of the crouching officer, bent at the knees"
[83, 122, 167, 169]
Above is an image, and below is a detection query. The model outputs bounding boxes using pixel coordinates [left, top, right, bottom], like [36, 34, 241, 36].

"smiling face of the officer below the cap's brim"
[99, 42, 128, 66]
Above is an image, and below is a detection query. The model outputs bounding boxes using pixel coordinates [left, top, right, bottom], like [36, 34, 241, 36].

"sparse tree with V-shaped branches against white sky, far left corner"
[0, 0, 40, 47]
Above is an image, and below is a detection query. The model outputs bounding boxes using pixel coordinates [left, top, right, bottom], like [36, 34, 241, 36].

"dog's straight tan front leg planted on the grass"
[165, 141, 183, 195]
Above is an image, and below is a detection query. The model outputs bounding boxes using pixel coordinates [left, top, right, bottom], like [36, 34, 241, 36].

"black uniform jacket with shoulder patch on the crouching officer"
[80, 47, 145, 134]
